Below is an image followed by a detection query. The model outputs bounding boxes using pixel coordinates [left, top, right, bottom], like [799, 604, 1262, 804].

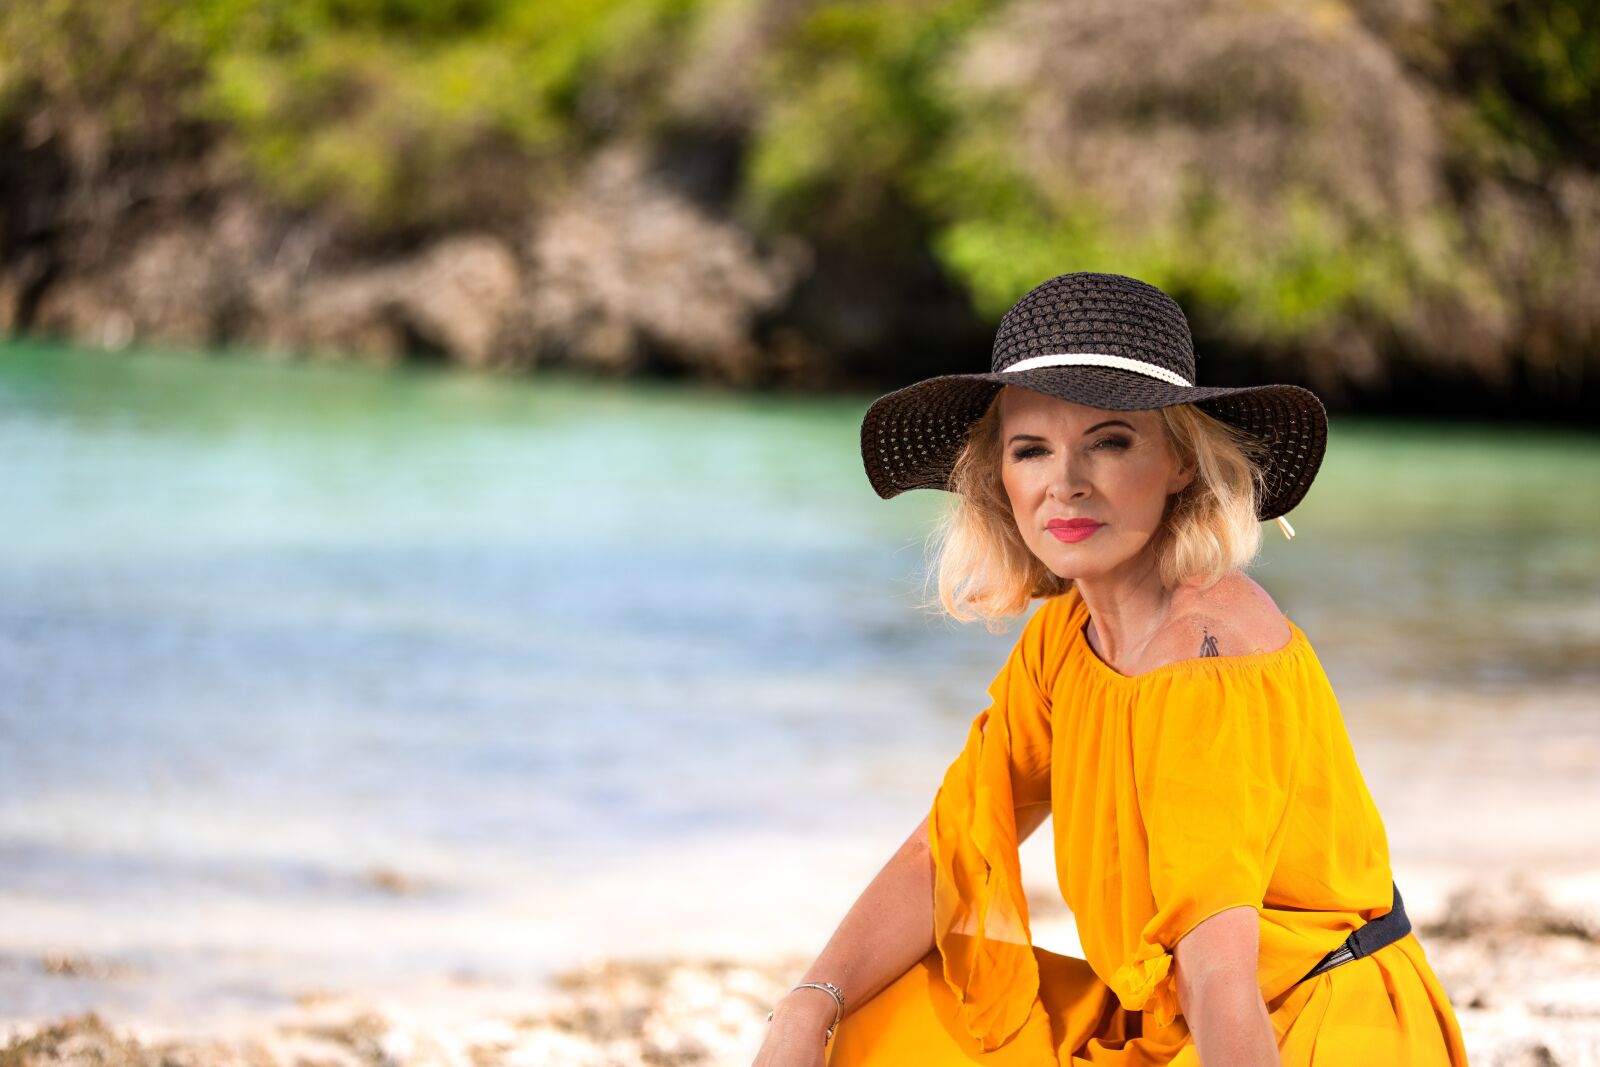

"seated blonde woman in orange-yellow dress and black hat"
[757, 274, 1467, 1067]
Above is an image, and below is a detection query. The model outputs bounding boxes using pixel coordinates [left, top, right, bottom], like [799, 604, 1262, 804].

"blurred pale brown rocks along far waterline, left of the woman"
[0, 144, 824, 384]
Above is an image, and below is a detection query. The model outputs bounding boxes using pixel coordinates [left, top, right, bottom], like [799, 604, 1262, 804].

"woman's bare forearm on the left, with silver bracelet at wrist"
[773, 819, 934, 1037]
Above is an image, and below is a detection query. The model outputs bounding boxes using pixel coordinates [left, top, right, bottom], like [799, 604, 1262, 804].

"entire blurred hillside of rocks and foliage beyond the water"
[0, 0, 1600, 416]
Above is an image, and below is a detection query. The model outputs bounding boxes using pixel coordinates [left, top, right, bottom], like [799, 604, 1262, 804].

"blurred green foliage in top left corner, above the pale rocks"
[0, 0, 694, 229]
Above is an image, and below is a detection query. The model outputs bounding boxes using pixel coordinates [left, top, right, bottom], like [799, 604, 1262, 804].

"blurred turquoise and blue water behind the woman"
[0, 344, 1600, 1011]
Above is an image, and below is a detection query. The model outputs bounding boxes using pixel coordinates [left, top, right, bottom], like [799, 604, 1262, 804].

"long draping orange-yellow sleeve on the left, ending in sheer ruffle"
[928, 597, 1059, 1051]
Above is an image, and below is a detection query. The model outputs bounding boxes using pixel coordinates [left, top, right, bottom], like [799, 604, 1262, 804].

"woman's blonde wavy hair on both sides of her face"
[922, 390, 1266, 633]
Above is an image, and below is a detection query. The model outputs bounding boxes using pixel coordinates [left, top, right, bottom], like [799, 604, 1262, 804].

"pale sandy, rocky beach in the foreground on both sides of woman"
[0, 877, 1600, 1067]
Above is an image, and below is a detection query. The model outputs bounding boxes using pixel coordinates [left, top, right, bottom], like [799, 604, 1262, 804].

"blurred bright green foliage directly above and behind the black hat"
[744, 0, 1440, 342]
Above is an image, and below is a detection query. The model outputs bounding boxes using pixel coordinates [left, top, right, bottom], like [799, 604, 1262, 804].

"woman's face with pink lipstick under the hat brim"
[998, 386, 1194, 579]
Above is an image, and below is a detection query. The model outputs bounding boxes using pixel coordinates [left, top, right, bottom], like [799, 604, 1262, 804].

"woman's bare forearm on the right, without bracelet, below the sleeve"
[1173, 907, 1282, 1067]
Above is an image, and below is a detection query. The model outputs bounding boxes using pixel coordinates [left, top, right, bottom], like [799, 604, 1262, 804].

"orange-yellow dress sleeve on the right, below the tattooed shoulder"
[1110, 659, 1304, 1027]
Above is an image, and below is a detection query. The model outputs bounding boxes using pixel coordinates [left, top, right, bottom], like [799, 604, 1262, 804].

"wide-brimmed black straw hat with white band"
[861, 272, 1328, 533]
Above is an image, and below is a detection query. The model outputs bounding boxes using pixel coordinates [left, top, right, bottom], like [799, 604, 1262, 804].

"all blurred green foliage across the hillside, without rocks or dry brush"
[0, 0, 1600, 361]
